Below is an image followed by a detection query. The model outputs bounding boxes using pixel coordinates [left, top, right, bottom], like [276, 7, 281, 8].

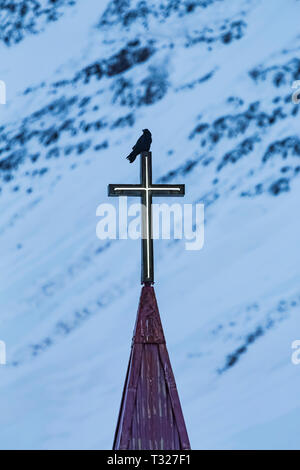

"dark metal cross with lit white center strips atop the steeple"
[108, 152, 185, 285]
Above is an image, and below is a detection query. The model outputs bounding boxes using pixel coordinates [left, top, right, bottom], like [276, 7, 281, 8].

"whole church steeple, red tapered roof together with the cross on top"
[108, 152, 190, 450]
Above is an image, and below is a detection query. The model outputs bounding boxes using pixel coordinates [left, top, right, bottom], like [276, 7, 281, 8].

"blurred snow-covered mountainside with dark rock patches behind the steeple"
[0, 0, 300, 449]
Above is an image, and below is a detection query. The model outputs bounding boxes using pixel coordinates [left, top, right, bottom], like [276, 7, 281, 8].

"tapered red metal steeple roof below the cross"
[113, 286, 190, 450]
